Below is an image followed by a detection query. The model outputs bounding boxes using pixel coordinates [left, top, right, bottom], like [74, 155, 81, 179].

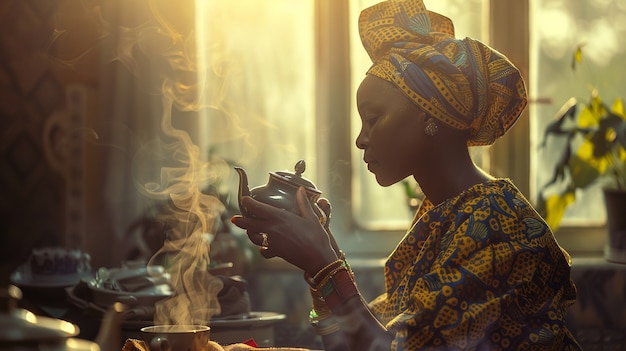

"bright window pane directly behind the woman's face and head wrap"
[350, 0, 487, 229]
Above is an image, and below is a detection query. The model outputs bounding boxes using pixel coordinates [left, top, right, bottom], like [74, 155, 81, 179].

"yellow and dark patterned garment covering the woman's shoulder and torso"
[371, 179, 580, 351]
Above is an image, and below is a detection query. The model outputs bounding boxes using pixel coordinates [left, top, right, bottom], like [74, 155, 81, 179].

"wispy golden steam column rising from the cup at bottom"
[145, 92, 224, 324]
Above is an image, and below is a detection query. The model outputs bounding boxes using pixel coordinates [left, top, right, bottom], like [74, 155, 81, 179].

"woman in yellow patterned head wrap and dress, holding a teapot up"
[233, 0, 580, 350]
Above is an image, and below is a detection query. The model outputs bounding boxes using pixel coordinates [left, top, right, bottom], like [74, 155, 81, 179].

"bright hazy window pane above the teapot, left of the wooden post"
[196, 0, 316, 189]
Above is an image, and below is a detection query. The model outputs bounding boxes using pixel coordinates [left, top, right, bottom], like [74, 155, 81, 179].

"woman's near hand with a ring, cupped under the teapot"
[231, 187, 339, 276]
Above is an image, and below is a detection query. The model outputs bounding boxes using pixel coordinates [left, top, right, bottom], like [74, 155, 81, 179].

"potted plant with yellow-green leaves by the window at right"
[537, 47, 626, 260]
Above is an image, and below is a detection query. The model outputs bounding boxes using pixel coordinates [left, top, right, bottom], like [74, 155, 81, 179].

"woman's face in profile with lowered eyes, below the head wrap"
[356, 75, 428, 186]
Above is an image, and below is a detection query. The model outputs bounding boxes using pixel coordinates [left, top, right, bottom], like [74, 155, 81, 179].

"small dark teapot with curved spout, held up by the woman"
[235, 160, 324, 219]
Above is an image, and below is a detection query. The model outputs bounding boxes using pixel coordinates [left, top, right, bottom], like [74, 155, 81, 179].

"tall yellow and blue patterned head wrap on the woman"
[359, 0, 527, 146]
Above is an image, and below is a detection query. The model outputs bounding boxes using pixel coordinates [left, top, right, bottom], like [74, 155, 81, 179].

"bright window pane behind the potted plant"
[530, 0, 626, 225]
